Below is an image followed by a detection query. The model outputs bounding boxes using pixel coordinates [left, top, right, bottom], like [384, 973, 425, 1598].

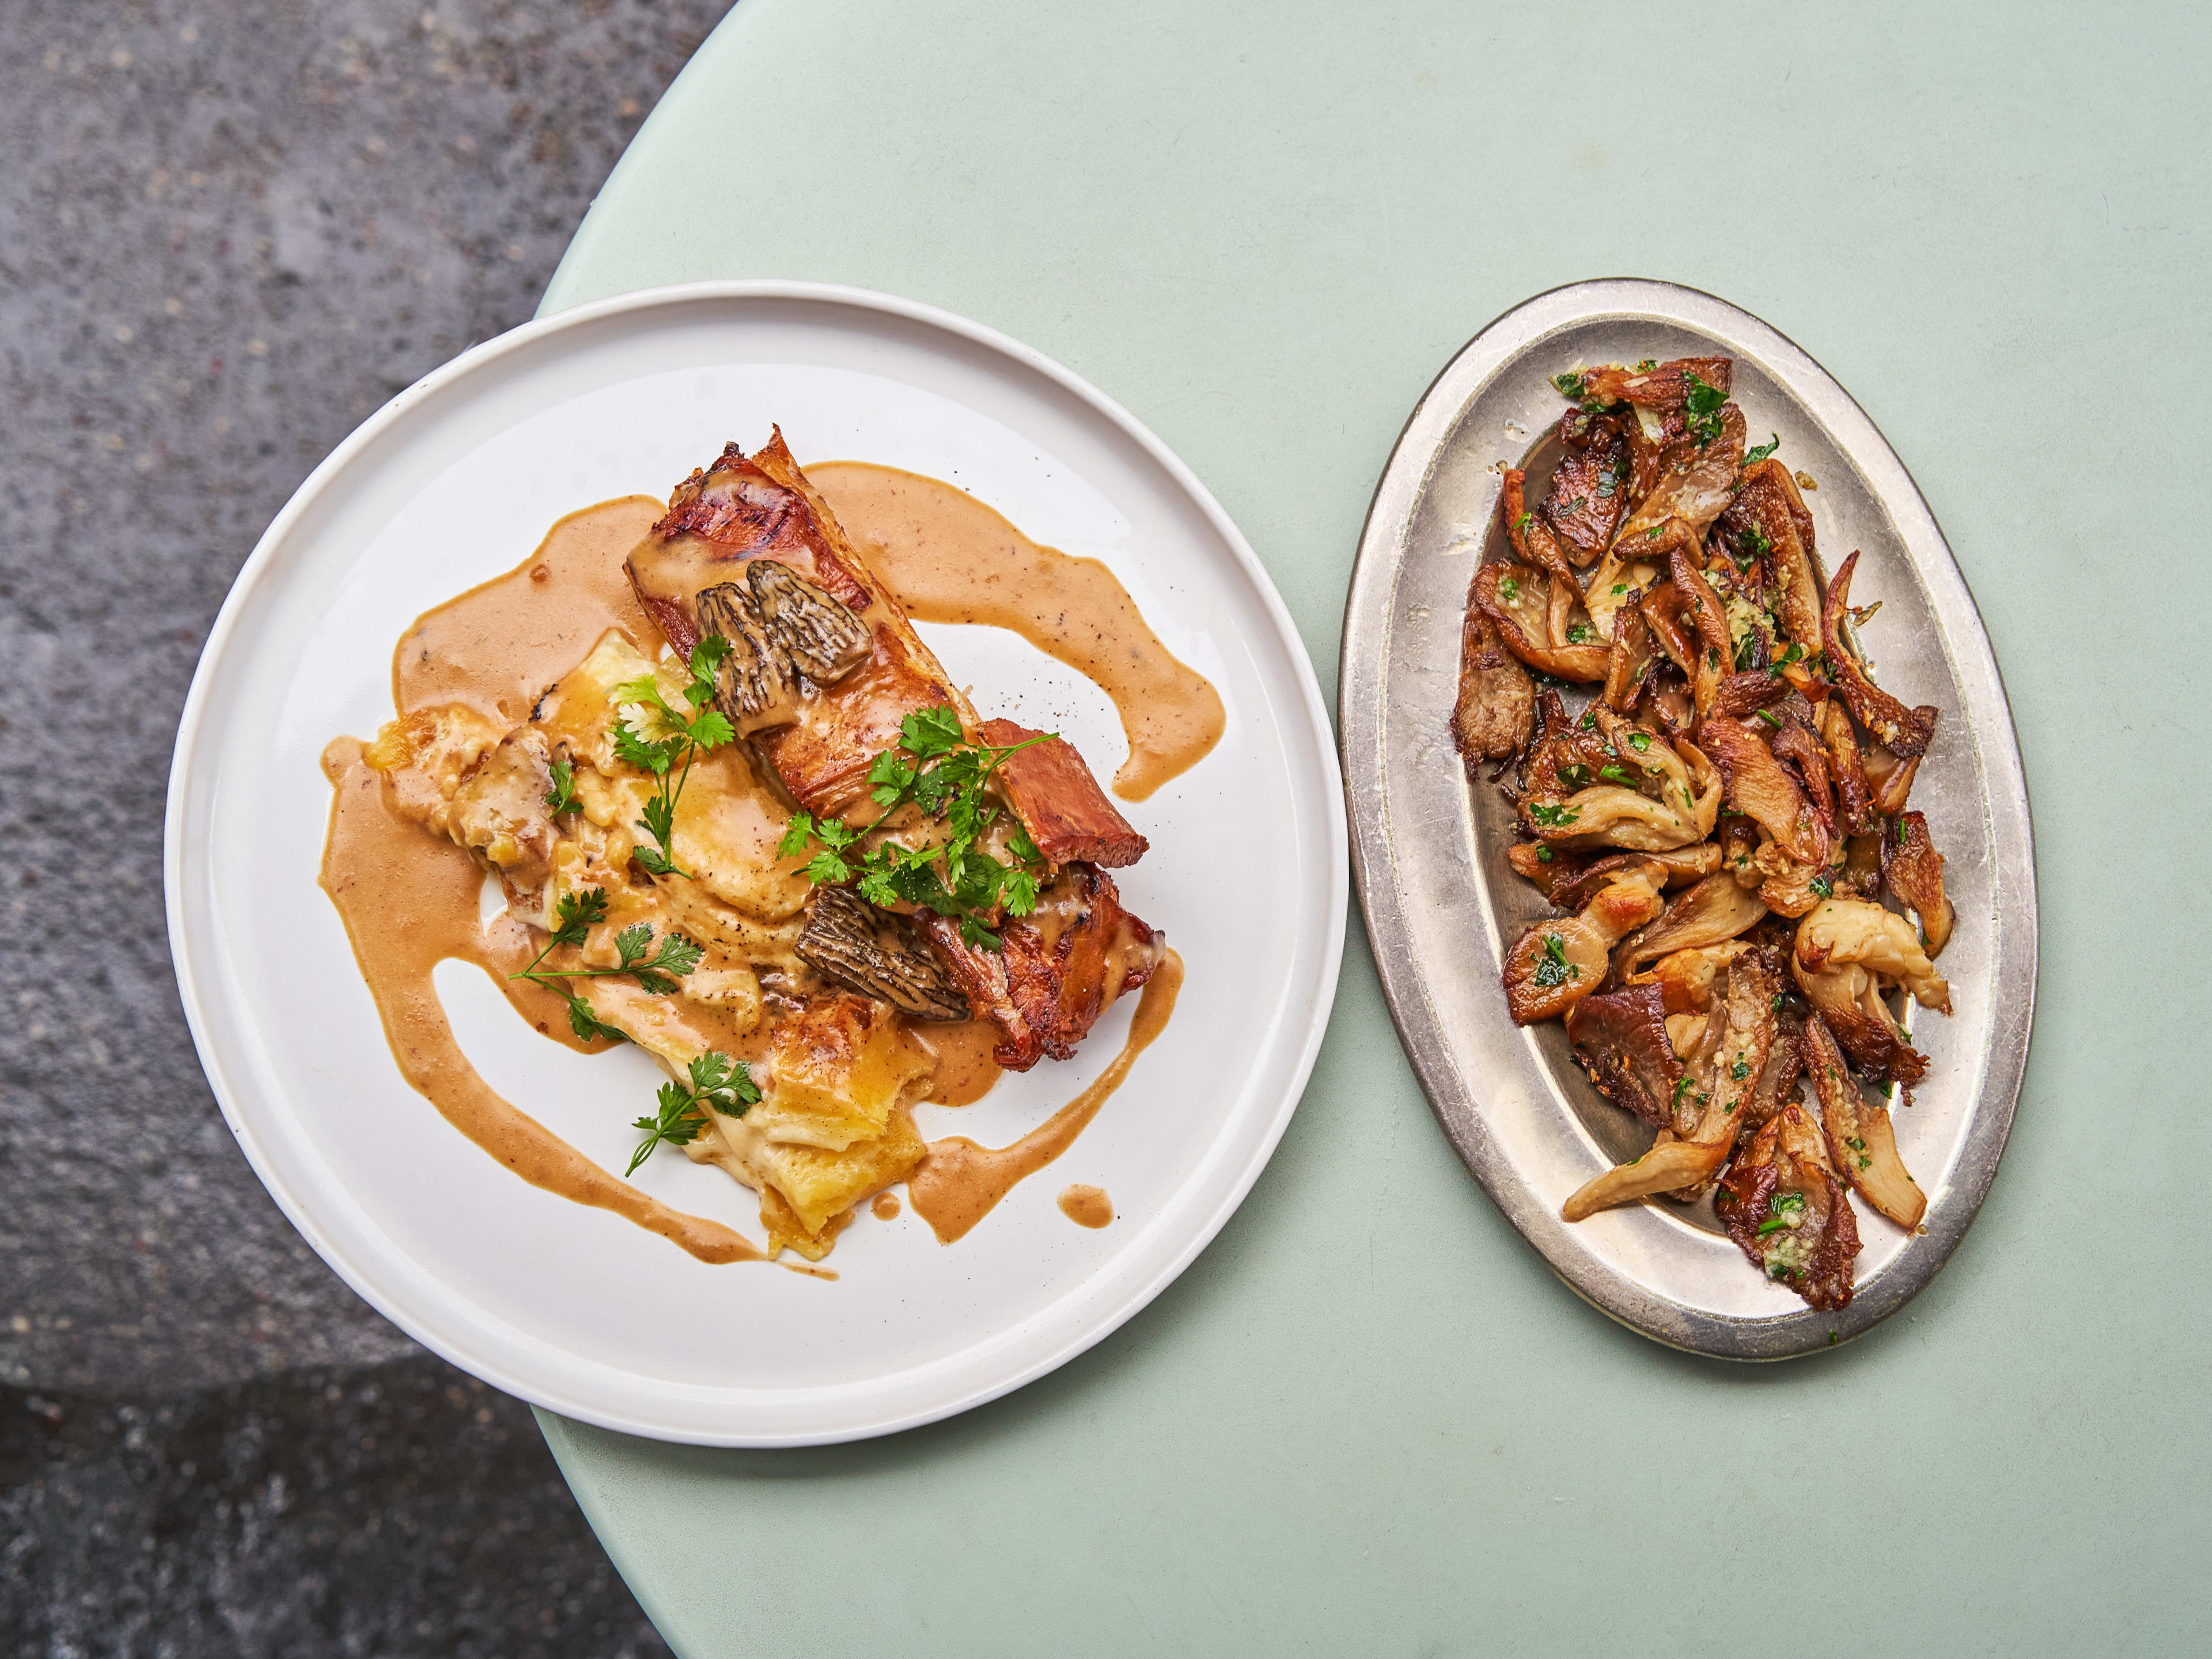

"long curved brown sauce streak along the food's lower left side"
[323, 737, 761, 1263]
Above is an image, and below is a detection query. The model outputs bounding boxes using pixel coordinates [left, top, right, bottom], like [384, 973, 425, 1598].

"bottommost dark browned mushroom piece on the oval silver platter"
[1712, 1101, 1858, 1309]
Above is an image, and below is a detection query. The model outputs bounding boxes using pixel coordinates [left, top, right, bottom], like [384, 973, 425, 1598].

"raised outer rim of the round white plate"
[161, 279, 1351, 1446]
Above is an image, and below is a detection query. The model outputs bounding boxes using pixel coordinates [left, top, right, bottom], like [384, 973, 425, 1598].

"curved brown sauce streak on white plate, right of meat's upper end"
[808, 460, 1225, 801]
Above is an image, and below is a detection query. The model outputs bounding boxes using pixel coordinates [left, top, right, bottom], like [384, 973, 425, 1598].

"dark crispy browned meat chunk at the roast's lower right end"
[922, 865, 1168, 1071]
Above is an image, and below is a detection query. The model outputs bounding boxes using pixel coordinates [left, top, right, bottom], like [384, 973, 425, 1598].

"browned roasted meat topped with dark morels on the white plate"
[628, 431, 1166, 1069]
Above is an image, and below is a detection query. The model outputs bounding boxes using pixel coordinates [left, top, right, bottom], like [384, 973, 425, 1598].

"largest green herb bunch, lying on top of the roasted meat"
[779, 708, 1051, 951]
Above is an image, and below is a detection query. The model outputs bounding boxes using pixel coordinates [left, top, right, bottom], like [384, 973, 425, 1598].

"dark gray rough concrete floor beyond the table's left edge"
[0, 0, 724, 1659]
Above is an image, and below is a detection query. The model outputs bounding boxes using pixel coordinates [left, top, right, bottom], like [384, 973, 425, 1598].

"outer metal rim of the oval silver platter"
[1338, 276, 2039, 1361]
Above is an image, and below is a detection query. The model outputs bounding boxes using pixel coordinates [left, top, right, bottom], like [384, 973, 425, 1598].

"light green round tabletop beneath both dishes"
[544, 0, 2212, 1659]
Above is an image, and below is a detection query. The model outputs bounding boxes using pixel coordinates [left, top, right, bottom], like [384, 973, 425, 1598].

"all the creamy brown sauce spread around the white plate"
[321, 480, 1194, 1279]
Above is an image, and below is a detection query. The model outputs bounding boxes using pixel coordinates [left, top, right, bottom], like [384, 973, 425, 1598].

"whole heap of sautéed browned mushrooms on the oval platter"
[1451, 356, 1956, 1309]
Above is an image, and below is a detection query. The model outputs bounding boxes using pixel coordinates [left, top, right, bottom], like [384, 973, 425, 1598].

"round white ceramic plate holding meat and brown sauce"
[166, 283, 1347, 1446]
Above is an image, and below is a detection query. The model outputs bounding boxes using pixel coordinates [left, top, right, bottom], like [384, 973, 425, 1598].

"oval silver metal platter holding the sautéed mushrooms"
[1338, 279, 2035, 1361]
